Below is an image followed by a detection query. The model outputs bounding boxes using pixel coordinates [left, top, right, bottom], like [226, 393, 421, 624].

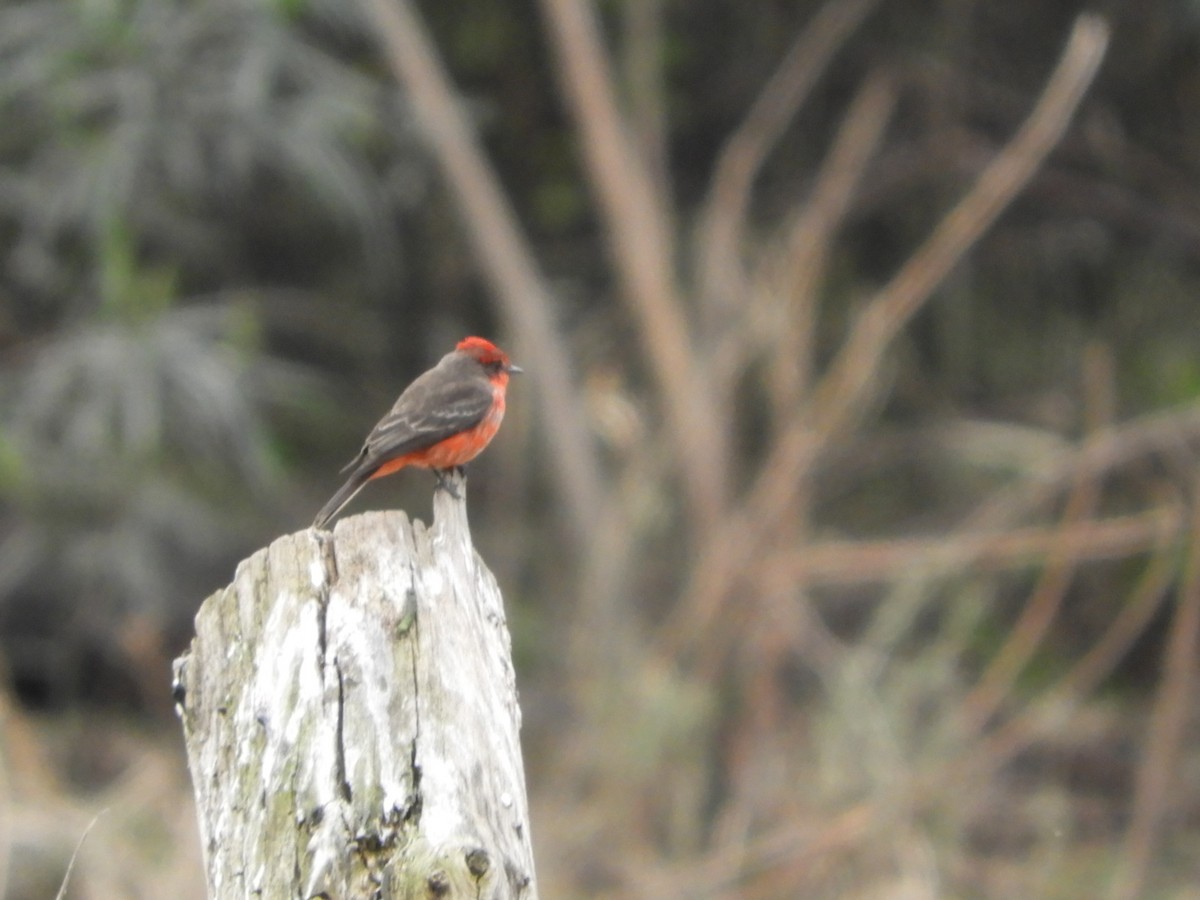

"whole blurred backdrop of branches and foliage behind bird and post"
[0, 0, 1200, 898]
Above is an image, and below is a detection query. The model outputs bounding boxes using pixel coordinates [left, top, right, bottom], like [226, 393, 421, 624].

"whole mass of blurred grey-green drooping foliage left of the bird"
[0, 0, 422, 662]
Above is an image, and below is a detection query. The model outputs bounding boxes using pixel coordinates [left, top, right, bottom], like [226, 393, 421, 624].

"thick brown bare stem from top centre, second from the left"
[541, 0, 728, 534]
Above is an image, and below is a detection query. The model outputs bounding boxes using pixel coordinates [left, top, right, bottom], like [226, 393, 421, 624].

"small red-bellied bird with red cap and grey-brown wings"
[312, 337, 521, 528]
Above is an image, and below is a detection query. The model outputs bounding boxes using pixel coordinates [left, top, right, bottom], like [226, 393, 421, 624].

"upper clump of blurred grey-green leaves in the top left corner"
[0, 0, 412, 307]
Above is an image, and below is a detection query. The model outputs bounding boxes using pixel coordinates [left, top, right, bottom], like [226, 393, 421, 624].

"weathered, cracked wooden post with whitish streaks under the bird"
[175, 478, 538, 900]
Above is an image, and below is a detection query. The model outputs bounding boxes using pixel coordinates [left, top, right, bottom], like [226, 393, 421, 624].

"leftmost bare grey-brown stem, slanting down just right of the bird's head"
[355, 0, 601, 544]
